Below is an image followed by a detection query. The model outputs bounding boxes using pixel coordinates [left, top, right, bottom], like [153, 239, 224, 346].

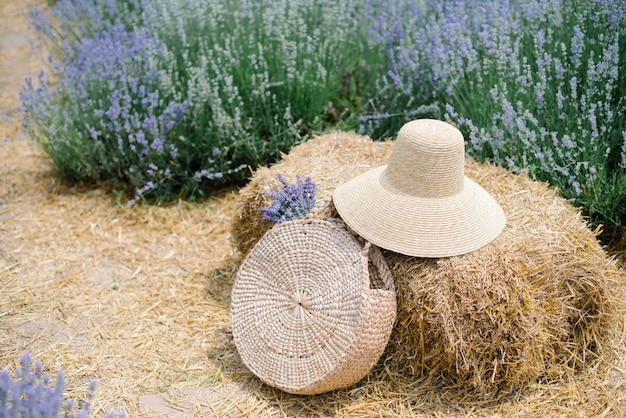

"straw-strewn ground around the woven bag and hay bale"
[0, 0, 626, 417]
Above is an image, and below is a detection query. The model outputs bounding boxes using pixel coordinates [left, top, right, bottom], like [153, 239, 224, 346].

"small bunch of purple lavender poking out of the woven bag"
[259, 174, 317, 224]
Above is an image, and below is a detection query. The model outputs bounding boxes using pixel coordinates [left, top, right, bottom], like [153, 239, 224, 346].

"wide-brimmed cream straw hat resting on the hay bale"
[333, 119, 506, 257]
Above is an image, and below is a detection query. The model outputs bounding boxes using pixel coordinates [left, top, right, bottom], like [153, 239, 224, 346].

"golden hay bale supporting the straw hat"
[232, 133, 626, 399]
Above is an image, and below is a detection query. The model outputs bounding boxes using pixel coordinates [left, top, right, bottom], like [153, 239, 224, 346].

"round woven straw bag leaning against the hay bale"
[231, 206, 396, 395]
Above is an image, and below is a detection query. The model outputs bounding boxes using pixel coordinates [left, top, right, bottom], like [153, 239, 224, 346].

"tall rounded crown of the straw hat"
[383, 119, 465, 198]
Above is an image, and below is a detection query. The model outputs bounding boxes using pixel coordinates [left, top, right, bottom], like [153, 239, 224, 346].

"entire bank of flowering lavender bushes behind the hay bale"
[22, 0, 626, 245]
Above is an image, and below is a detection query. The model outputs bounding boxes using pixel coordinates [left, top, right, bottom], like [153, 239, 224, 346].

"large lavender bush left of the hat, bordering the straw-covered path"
[22, 0, 361, 203]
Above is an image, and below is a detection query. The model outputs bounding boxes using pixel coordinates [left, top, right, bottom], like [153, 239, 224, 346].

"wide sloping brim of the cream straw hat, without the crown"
[333, 165, 506, 258]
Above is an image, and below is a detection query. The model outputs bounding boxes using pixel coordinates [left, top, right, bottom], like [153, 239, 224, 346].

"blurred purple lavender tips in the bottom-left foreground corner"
[0, 353, 95, 418]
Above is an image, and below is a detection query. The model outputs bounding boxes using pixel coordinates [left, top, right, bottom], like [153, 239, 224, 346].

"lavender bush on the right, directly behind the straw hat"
[363, 0, 626, 242]
